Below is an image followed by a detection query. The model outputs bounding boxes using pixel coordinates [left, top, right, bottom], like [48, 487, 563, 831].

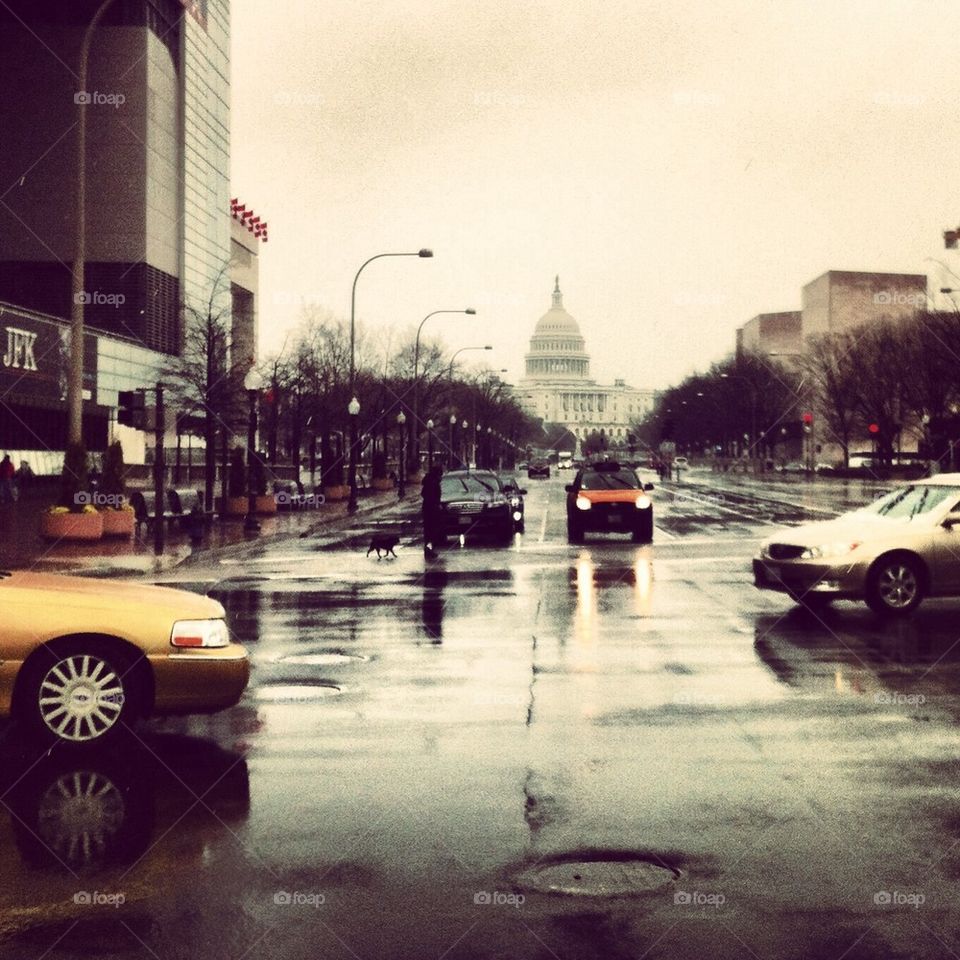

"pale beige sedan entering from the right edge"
[753, 473, 960, 615]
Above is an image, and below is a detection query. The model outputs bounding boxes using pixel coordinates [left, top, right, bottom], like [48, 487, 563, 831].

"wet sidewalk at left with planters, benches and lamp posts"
[0, 486, 410, 577]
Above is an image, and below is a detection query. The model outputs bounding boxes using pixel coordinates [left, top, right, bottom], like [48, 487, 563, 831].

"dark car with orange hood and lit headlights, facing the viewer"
[566, 460, 653, 543]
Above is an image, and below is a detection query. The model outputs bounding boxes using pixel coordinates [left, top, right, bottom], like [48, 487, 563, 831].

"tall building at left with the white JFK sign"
[0, 0, 256, 457]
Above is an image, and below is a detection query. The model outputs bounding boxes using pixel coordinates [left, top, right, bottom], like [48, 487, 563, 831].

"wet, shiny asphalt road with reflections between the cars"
[0, 474, 960, 960]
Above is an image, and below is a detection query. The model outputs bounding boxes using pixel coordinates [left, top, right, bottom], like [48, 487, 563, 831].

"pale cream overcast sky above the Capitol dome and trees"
[231, 0, 960, 387]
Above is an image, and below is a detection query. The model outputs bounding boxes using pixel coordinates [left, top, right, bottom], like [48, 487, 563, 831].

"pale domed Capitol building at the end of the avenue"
[517, 277, 654, 450]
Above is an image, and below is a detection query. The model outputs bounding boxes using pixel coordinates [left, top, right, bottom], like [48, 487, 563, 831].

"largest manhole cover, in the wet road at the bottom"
[515, 860, 679, 897]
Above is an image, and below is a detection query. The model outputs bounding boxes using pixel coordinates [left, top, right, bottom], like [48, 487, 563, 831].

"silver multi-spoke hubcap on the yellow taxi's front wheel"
[39, 654, 123, 741]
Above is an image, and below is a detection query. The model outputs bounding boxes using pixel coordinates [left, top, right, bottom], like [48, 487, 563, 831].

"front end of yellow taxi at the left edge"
[0, 571, 249, 744]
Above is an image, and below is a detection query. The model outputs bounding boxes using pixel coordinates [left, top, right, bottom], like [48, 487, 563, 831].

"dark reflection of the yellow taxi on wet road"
[0, 734, 250, 935]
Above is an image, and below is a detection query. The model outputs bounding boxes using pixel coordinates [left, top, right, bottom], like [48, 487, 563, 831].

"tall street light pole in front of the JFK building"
[67, 0, 113, 444]
